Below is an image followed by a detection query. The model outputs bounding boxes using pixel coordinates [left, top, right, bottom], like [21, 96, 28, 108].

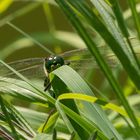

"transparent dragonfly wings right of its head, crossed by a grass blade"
[61, 47, 119, 69]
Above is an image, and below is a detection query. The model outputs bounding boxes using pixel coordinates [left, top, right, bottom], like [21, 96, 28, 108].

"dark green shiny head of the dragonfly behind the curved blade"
[45, 56, 64, 73]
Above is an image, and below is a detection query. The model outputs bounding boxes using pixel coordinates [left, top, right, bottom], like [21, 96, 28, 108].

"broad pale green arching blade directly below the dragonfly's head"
[52, 66, 121, 139]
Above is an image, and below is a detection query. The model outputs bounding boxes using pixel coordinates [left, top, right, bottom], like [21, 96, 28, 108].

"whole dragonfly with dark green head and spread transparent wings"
[0, 41, 139, 91]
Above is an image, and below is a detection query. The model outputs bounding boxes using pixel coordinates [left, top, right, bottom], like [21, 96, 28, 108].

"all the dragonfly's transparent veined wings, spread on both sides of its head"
[0, 36, 140, 78]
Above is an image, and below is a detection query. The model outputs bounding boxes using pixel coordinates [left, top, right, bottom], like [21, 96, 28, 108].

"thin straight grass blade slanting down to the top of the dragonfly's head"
[6, 22, 54, 54]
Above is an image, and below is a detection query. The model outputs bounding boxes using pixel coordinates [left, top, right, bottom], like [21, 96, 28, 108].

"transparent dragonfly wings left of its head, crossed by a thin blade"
[0, 58, 45, 79]
